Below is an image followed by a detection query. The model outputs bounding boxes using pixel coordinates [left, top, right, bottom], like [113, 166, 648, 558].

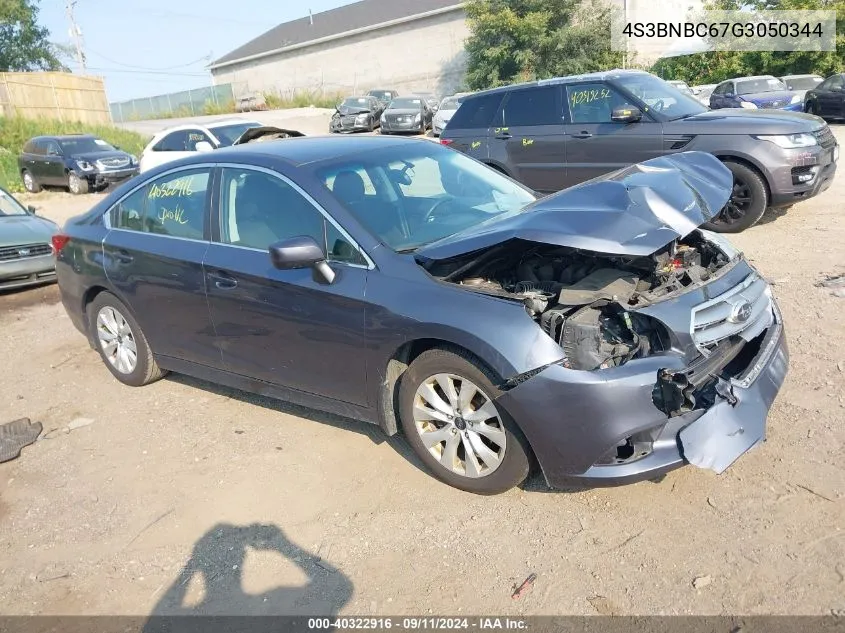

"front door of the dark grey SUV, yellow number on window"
[565, 82, 663, 186]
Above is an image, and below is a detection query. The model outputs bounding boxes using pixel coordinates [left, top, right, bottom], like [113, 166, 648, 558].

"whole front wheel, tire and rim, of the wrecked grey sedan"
[399, 349, 530, 495]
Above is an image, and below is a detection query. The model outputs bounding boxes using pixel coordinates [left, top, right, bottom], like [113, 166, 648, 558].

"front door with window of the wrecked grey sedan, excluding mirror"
[204, 167, 368, 405]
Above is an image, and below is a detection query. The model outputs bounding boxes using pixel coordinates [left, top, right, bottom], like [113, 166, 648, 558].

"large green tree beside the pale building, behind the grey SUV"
[466, 0, 622, 90]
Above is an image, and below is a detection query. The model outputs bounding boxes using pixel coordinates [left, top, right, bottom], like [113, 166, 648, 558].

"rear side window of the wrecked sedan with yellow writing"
[112, 169, 210, 240]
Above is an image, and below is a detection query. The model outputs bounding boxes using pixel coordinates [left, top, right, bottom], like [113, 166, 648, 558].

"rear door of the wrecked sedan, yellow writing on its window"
[103, 165, 222, 368]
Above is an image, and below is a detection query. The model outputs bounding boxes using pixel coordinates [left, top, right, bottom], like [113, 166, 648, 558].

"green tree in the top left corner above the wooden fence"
[0, 0, 63, 72]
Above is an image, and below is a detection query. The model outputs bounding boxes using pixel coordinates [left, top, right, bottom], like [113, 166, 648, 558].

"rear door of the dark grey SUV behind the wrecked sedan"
[490, 86, 566, 193]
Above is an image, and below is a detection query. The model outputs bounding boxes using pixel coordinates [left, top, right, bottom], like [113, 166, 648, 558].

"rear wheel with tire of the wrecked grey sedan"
[88, 292, 165, 387]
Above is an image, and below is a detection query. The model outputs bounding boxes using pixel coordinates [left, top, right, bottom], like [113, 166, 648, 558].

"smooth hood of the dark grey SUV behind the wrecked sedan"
[663, 108, 825, 135]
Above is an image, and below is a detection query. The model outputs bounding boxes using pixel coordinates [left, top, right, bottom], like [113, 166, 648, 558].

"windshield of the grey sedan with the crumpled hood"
[317, 143, 536, 252]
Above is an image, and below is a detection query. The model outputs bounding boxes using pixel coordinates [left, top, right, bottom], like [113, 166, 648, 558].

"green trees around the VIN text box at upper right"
[652, 0, 845, 84]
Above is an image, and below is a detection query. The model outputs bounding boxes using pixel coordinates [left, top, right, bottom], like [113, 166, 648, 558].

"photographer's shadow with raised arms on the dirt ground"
[143, 523, 353, 633]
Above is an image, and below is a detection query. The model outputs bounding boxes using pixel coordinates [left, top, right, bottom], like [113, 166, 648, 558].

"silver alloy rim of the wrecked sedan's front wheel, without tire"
[413, 374, 507, 478]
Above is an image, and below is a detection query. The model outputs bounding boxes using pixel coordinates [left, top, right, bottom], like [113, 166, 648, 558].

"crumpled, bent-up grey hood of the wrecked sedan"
[416, 152, 733, 260]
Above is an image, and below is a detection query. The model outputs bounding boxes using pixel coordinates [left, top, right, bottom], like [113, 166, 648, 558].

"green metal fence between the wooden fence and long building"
[109, 84, 235, 123]
